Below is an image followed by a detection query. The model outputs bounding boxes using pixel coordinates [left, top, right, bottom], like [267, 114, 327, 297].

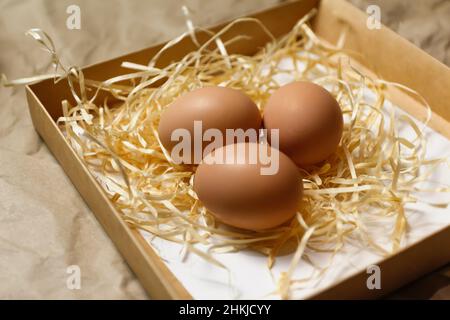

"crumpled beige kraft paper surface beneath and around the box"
[0, 0, 450, 299]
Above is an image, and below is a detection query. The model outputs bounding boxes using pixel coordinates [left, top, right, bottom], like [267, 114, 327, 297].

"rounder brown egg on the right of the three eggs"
[263, 81, 343, 167]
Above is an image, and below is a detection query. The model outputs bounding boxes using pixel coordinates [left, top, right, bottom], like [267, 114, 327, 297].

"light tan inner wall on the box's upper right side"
[313, 0, 450, 127]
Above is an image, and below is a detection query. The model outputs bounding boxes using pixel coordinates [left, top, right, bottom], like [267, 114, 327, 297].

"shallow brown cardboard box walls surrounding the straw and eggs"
[26, 0, 450, 299]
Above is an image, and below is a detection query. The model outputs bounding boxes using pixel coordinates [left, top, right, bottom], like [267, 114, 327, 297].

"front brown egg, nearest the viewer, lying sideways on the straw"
[194, 143, 303, 230]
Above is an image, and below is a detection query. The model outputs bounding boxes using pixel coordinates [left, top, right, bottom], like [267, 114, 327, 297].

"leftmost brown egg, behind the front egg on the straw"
[158, 87, 262, 164]
